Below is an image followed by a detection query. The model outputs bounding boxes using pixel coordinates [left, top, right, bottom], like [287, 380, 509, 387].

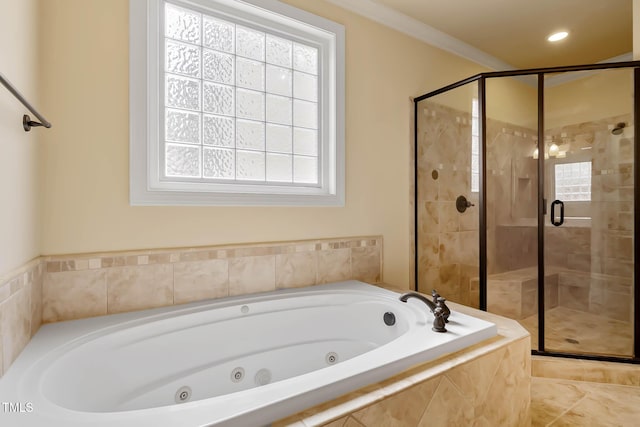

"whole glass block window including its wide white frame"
[129, 0, 345, 206]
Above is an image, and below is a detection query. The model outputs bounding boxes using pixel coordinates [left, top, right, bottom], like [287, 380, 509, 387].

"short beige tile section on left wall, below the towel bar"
[0, 259, 44, 376]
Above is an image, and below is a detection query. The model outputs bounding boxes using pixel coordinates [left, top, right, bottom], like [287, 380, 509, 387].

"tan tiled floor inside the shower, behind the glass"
[519, 307, 633, 356]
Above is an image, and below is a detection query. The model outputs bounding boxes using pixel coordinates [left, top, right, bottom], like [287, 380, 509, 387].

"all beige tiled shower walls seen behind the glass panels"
[417, 101, 633, 320]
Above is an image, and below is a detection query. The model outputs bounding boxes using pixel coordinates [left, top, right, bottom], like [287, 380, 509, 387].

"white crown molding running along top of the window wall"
[327, 0, 514, 71]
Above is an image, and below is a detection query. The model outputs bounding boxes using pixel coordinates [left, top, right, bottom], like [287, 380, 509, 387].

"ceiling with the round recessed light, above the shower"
[342, 0, 633, 68]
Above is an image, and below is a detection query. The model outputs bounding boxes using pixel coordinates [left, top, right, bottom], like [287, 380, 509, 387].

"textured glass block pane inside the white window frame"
[162, 3, 319, 185]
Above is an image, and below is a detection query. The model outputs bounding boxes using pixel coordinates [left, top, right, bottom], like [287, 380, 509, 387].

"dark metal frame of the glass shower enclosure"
[413, 61, 640, 364]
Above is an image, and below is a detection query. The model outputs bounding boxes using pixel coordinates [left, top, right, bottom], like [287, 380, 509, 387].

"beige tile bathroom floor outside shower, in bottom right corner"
[531, 377, 640, 427]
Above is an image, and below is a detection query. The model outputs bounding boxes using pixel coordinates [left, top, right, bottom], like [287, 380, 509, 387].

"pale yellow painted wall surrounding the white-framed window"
[40, 0, 490, 286]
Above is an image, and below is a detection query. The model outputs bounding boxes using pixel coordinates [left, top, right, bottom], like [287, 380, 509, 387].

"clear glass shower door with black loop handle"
[538, 70, 634, 356]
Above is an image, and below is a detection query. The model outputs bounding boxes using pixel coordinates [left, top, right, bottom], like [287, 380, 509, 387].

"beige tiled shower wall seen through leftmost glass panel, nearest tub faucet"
[417, 102, 478, 305]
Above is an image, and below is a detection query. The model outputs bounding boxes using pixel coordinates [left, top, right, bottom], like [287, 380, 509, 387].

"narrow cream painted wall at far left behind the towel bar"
[0, 0, 40, 276]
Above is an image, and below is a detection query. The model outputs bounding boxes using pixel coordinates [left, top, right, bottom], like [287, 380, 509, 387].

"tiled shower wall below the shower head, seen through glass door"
[545, 115, 634, 321]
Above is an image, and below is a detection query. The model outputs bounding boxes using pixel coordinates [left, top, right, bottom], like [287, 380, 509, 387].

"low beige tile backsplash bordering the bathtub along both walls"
[0, 236, 382, 378]
